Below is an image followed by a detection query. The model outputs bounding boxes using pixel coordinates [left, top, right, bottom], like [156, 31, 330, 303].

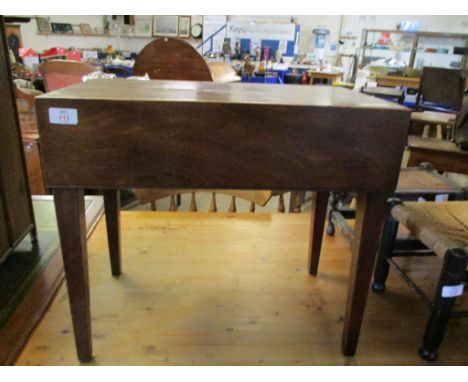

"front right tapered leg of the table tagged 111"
[341, 193, 390, 356]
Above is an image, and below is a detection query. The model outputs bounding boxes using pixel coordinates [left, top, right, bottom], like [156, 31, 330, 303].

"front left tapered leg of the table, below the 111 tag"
[53, 188, 93, 362]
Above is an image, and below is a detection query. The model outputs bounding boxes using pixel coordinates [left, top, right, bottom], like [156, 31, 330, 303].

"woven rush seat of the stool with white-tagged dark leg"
[391, 201, 468, 257]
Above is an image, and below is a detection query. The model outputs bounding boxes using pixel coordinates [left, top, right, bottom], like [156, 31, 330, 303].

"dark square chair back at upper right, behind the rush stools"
[417, 67, 464, 110]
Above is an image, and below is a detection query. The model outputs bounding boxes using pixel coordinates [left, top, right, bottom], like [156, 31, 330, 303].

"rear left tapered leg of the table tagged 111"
[103, 190, 122, 276]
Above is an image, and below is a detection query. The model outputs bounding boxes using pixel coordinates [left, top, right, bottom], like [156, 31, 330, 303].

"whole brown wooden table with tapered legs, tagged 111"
[36, 79, 410, 362]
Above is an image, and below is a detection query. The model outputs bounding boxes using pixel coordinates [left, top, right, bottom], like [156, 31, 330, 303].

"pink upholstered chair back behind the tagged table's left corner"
[39, 60, 98, 92]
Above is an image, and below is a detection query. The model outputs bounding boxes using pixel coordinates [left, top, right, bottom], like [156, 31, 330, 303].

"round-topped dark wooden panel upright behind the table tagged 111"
[133, 37, 213, 81]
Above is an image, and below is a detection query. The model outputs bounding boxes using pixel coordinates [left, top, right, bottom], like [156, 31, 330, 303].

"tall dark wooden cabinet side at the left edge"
[0, 17, 35, 262]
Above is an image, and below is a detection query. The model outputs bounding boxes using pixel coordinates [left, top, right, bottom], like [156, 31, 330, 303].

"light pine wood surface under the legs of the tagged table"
[17, 211, 468, 365]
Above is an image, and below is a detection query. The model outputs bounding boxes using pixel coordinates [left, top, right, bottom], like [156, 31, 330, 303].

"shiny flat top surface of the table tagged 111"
[36, 79, 405, 106]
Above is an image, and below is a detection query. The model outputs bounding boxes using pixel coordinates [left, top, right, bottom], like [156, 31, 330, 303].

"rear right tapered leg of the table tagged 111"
[308, 191, 329, 276]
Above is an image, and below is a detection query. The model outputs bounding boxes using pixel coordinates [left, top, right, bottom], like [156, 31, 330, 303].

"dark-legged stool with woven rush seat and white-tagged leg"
[372, 199, 468, 361]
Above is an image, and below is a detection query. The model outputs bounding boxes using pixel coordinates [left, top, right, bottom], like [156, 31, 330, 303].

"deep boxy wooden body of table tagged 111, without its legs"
[37, 81, 409, 191]
